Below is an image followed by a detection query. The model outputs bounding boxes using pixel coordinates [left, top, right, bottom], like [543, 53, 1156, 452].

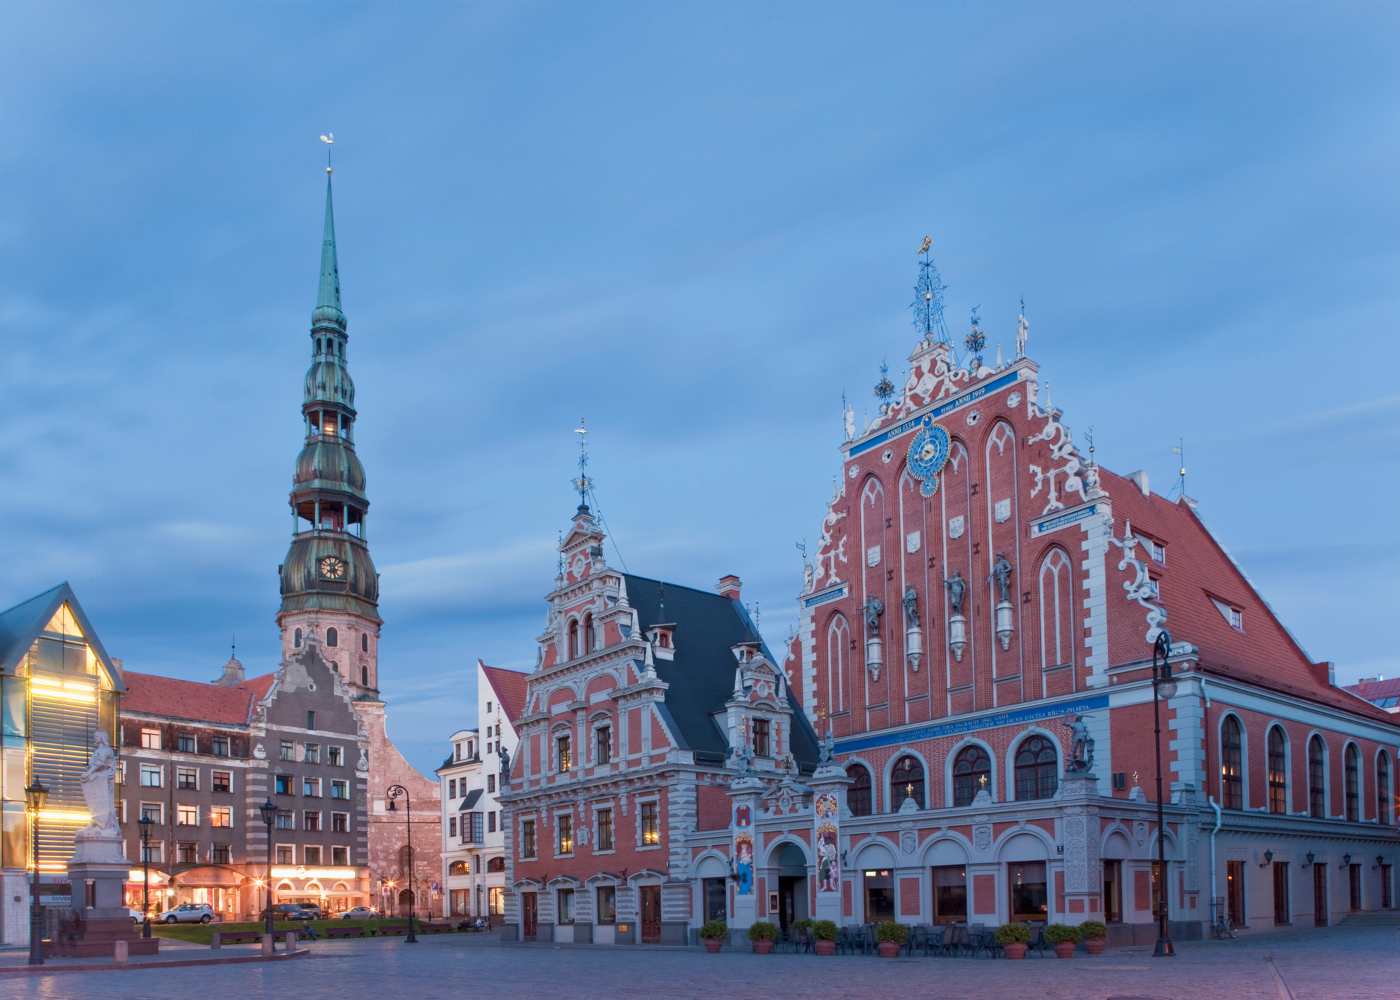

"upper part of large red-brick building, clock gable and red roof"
[784, 275, 1388, 737]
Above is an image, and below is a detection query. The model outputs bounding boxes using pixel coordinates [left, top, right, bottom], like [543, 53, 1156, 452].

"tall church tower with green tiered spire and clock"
[277, 167, 381, 700]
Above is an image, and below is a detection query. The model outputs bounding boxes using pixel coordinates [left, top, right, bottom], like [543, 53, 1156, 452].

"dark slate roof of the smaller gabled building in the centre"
[624, 573, 818, 770]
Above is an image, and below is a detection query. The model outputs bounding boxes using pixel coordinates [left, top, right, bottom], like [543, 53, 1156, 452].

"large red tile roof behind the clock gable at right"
[1099, 469, 1394, 724]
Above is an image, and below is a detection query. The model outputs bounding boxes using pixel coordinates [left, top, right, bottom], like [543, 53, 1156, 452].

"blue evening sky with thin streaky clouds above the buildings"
[0, 3, 1400, 768]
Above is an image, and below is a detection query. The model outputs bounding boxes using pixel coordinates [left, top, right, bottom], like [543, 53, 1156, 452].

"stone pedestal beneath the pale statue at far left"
[45, 828, 161, 958]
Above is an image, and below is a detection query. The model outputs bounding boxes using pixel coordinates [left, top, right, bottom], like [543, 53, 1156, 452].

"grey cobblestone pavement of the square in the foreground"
[0, 926, 1400, 1000]
